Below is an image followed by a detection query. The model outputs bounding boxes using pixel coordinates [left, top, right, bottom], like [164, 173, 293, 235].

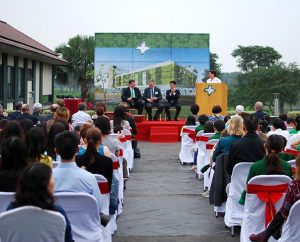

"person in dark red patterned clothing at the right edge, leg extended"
[249, 155, 300, 242]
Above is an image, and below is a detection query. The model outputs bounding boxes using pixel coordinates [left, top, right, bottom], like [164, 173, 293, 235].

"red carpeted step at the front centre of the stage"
[149, 126, 179, 143]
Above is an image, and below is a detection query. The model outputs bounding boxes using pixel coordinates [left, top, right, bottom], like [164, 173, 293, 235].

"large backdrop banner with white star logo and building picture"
[94, 33, 209, 103]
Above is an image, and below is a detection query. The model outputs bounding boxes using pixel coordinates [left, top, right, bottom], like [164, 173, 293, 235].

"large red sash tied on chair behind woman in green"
[247, 184, 288, 227]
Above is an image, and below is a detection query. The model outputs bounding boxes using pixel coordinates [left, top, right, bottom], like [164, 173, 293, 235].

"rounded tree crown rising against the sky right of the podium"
[231, 45, 282, 72]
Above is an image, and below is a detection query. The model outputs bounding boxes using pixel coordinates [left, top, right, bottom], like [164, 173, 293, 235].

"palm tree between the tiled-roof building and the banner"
[55, 35, 95, 100]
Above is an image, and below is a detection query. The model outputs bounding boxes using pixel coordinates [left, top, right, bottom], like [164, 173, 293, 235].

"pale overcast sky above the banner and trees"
[0, 0, 300, 72]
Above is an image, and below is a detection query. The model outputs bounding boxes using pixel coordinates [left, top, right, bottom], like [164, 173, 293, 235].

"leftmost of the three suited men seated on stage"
[121, 80, 144, 114]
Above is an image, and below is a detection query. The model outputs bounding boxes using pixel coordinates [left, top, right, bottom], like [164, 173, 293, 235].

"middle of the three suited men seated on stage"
[143, 80, 164, 120]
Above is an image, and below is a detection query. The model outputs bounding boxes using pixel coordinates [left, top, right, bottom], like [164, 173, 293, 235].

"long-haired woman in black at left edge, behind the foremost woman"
[0, 136, 28, 192]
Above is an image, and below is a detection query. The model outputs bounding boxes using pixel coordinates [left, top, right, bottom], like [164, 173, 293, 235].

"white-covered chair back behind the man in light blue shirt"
[54, 192, 103, 242]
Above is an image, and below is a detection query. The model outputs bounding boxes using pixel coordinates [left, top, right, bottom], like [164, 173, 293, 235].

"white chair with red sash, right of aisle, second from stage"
[196, 130, 214, 179]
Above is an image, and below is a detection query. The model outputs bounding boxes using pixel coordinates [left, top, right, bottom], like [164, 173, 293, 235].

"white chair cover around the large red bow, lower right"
[240, 175, 291, 242]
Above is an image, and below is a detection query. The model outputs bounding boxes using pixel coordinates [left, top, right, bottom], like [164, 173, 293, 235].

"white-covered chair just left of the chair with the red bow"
[224, 162, 253, 236]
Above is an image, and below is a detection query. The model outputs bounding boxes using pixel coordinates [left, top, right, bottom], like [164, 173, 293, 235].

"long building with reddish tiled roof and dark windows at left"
[0, 21, 68, 109]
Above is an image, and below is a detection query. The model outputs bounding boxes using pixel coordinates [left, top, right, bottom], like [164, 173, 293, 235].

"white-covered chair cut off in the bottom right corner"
[278, 200, 300, 242]
